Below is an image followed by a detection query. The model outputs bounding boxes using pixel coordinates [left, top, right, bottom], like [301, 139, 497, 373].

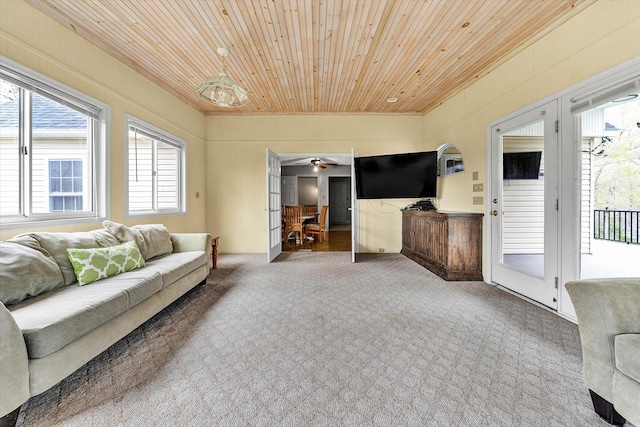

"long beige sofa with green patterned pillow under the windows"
[0, 221, 212, 419]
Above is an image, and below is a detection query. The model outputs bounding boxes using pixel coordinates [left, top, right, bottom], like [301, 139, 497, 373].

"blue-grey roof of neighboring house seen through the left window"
[0, 94, 87, 129]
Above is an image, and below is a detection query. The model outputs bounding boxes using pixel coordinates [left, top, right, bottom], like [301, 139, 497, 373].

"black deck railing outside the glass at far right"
[593, 209, 640, 244]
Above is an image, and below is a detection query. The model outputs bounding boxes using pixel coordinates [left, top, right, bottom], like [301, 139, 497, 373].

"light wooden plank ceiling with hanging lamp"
[27, 0, 591, 114]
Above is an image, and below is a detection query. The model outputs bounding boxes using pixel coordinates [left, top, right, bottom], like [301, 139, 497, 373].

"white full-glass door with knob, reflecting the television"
[488, 101, 559, 309]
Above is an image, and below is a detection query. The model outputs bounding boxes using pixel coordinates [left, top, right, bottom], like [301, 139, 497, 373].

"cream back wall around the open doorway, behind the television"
[206, 115, 424, 253]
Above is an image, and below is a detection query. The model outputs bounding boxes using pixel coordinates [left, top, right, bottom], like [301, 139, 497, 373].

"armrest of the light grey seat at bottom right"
[566, 278, 640, 402]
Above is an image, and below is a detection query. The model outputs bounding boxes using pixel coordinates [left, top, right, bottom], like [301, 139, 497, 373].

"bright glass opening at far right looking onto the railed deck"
[573, 86, 640, 279]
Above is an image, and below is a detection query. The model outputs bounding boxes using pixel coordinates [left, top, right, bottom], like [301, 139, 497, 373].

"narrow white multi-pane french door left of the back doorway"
[267, 148, 282, 262]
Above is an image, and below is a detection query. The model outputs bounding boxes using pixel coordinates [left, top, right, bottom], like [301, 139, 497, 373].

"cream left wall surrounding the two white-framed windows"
[0, 0, 206, 239]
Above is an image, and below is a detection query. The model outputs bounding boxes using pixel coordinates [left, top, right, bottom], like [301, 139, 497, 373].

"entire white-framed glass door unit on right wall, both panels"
[485, 59, 640, 320]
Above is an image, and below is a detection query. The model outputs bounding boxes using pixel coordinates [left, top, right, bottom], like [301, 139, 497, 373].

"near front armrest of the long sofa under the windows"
[0, 302, 31, 416]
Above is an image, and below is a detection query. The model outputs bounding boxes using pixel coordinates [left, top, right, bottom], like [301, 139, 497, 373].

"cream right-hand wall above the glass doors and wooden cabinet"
[424, 0, 640, 212]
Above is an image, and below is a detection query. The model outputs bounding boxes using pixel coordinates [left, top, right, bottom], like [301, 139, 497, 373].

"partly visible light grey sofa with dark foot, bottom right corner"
[566, 278, 640, 426]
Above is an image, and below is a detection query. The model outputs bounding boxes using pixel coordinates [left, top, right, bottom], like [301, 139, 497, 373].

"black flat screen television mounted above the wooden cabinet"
[354, 151, 438, 199]
